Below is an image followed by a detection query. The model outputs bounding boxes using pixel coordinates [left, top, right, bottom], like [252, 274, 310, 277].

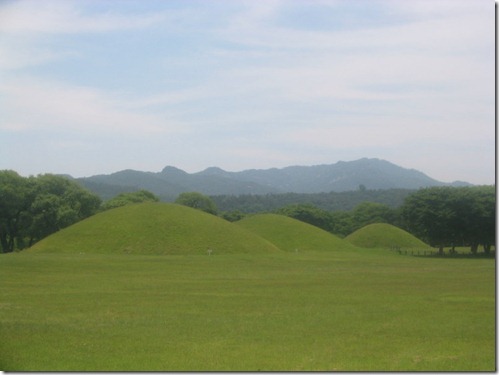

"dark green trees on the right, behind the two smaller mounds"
[266, 186, 496, 253]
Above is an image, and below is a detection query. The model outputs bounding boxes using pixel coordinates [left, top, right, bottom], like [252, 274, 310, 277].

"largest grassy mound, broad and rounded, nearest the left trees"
[28, 203, 280, 255]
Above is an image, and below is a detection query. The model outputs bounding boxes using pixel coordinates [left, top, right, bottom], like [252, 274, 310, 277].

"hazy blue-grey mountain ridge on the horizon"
[76, 158, 471, 200]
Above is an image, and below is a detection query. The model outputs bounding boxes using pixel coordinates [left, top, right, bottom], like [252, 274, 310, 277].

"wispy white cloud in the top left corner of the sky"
[0, 0, 167, 72]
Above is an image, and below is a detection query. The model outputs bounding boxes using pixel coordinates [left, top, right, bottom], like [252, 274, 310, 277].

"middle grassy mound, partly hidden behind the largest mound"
[237, 214, 352, 251]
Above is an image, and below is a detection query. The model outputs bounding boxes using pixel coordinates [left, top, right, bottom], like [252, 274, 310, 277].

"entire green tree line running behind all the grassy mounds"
[0, 170, 496, 253]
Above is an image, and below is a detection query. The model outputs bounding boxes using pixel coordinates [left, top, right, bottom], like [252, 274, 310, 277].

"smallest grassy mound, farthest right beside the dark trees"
[345, 223, 430, 249]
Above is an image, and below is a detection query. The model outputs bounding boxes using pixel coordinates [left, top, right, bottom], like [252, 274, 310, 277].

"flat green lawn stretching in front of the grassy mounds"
[0, 249, 495, 371]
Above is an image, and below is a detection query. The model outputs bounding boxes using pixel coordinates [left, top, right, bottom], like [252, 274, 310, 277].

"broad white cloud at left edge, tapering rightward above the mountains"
[0, 78, 185, 137]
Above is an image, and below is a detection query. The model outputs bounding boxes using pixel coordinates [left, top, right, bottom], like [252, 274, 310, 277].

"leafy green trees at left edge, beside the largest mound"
[0, 170, 101, 253]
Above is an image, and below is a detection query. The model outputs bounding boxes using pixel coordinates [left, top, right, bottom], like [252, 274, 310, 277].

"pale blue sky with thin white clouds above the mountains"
[0, 0, 496, 184]
